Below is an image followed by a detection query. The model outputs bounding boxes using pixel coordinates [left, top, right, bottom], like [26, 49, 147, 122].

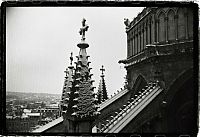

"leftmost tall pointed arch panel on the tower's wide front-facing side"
[158, 12, 165, 42]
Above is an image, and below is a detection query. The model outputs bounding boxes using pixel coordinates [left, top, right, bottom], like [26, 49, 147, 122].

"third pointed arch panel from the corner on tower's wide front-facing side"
[178, 8, 185, 39]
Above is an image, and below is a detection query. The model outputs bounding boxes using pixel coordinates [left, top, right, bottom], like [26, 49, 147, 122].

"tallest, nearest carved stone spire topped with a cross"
[62, 19, 99, 127]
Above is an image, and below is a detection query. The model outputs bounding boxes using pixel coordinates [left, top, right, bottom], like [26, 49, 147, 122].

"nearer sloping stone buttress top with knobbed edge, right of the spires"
[98, 83, 162, 133]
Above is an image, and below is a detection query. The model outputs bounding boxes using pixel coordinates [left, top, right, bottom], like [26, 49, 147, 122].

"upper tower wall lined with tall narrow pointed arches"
[127, 7, 193, 58]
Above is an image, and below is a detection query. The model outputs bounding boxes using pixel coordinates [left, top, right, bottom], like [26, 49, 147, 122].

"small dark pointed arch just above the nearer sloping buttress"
[131, 75, 147, 98]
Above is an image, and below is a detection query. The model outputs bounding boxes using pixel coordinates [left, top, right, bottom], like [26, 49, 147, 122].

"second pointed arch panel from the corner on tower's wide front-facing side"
[167, 10, 175, 40]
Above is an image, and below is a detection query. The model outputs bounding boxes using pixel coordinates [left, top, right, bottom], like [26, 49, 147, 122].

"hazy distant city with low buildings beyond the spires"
[6, 91, 61, 132]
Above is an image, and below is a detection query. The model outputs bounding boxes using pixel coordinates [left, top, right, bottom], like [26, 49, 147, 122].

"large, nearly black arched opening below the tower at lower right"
[166, 71, 197, 133]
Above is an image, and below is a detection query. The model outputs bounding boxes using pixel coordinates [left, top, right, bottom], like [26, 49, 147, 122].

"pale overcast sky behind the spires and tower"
[6, 7, 143, 96]
